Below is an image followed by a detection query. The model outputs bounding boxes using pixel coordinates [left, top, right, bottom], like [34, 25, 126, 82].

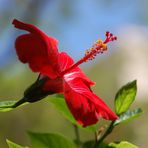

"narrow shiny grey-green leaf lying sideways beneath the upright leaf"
[114, 108, 143, 126]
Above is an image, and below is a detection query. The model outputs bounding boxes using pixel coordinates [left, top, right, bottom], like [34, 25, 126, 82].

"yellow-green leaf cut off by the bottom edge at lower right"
[107, 141, 138, 148]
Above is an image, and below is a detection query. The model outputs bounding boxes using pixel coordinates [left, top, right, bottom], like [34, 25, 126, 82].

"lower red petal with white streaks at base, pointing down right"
[64, 76, 117, 126]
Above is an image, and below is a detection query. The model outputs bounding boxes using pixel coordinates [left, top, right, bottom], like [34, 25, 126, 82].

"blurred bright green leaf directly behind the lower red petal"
[48, 95, 97, 132]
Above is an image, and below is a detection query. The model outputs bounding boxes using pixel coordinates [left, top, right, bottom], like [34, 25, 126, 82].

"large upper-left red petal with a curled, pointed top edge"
[13, 20, 59, 78]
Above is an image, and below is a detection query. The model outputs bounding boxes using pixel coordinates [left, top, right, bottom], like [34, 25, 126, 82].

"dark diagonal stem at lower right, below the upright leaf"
[93, 121, 114, 148]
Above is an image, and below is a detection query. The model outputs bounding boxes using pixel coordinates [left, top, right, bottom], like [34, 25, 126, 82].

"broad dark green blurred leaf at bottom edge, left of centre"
[29, 132, 76, 148]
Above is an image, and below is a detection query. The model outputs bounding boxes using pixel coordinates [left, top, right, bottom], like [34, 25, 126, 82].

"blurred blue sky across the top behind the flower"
[0, 0, 146, 67]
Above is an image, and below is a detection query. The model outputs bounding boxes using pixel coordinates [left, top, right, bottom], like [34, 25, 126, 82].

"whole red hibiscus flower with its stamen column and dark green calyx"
[13, 19, 117, 126]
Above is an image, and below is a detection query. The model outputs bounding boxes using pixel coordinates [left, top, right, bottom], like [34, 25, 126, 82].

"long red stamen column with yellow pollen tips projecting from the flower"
[60, 31, 117, 76]
